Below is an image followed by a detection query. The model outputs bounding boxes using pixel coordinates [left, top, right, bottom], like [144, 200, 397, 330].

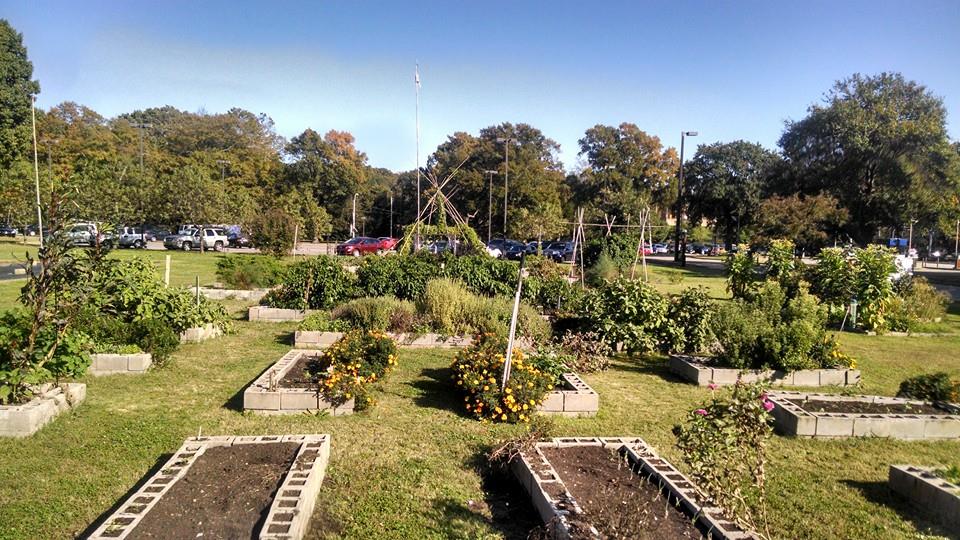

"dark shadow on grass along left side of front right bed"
[433, 449, 542, 540]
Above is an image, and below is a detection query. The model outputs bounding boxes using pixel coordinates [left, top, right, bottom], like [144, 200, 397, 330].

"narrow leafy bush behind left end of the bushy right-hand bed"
[663, 287, 714, 353]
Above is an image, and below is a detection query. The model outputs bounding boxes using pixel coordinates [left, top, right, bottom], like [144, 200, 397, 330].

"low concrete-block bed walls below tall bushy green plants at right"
[670, 355, 860, 387]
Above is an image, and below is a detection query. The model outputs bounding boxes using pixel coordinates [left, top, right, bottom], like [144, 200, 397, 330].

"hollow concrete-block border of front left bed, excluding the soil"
[90, 435, 330, 540]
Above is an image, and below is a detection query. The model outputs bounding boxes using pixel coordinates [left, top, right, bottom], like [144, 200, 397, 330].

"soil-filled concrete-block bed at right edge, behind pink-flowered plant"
[768, 392, 960, 440]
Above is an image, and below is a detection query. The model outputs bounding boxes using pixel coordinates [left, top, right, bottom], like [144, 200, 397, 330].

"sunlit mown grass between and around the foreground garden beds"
[0, 294, 960, 539]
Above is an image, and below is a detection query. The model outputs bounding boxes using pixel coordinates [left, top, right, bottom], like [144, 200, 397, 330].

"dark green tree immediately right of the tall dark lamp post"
[684, 141, 778, 249]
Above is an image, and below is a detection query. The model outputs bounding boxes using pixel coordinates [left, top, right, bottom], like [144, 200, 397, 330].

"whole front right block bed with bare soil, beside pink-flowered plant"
[511, 438, 755, 539]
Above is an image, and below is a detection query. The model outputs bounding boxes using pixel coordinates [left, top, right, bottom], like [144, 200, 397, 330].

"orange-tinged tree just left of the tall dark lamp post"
[574, 122, 679, 222]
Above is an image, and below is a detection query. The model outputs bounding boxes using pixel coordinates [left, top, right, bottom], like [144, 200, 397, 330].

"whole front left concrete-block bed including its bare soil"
[90, 435, 330, 540]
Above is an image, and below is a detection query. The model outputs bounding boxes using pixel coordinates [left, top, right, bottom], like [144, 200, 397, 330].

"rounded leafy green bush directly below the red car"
[260, 255, 354, 309]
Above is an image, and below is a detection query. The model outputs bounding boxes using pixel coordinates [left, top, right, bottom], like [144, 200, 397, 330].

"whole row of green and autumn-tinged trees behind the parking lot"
[0, 20, 960, 248]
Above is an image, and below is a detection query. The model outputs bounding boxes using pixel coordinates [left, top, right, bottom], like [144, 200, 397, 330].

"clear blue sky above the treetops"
[7, 0, 960, 170]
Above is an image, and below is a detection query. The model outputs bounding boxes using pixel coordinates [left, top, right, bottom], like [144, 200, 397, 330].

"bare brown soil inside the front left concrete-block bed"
[128, 442, 300, 540]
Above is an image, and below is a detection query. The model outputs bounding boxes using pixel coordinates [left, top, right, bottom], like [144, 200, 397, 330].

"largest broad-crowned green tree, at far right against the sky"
[780, 73, 958, 243]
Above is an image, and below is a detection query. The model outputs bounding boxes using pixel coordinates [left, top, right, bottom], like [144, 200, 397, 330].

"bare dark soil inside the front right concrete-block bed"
[542, 446, 703, 540]
